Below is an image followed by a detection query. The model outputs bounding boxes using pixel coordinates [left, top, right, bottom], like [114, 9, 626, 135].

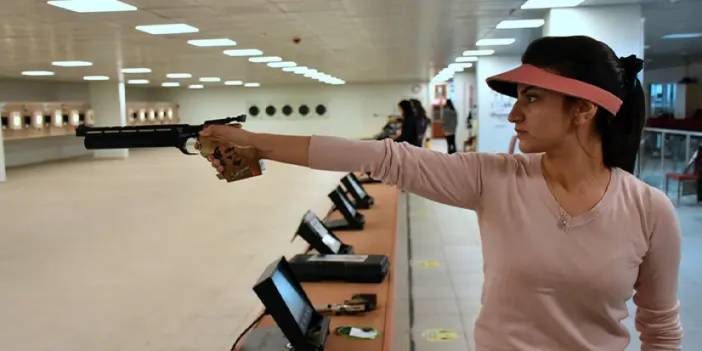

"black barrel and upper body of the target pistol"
[76, 115, 246, 155]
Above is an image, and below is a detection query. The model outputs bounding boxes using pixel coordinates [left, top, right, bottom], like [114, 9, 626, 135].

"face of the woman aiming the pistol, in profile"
[509, 84, 575, 153]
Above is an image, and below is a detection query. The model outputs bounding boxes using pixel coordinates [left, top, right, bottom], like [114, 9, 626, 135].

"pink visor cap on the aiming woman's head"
[487, 64, 622, 116]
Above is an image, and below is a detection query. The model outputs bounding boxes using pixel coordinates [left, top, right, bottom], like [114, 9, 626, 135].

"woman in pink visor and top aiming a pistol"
[202, 36, 682, 350]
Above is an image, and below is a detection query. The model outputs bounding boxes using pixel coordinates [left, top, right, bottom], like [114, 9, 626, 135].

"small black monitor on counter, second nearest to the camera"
[297, 211, 352, 255]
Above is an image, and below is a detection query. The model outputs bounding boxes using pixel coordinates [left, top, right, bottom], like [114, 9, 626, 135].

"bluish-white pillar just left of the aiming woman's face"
[476, 56, 521, 153]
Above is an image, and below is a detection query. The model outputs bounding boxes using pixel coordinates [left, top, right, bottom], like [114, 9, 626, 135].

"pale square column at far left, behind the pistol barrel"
[90, 81, 129, 158]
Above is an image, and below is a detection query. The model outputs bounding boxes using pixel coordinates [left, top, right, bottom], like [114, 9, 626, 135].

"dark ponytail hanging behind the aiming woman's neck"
[595, 55, 646, 173]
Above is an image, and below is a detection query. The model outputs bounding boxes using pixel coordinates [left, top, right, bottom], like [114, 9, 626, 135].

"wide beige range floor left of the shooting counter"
[0, 149, 342, 351]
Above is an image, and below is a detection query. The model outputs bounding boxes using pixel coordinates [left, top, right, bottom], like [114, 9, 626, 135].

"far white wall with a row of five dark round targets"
[148, 83, 428, 138]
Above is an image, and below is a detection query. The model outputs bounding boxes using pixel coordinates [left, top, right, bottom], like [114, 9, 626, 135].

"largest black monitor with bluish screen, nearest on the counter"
[253, 257, 328, 351]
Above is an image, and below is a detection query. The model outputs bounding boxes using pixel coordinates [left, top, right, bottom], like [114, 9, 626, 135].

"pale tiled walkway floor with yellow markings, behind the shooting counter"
[408, 140, 702, 351]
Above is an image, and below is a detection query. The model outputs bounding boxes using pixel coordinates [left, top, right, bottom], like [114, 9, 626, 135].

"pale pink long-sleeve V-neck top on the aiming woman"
[309, 136, 682, 351]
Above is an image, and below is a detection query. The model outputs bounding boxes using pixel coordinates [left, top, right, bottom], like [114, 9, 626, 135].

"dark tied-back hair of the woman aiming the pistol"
[522, 36, 646, 172]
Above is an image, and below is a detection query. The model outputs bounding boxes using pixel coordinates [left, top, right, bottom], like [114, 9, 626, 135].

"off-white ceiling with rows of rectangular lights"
[0, 0, 702, 85]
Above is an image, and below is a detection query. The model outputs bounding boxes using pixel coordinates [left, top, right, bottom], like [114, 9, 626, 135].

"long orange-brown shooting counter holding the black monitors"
[238, 184, 409, 351]
